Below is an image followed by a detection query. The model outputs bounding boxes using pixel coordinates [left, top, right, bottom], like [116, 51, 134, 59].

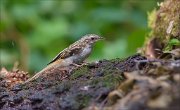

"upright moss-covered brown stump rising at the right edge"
[142, 0, 180, 56]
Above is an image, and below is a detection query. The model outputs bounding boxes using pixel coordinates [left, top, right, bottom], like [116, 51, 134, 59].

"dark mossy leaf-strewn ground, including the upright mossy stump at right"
[0, 0, 180, 110]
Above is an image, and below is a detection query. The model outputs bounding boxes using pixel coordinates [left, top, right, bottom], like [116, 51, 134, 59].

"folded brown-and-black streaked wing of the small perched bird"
[48, 45, 82, 65]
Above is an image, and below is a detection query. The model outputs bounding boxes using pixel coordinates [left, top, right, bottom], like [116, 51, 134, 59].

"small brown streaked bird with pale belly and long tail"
[25, 34, 104, 83]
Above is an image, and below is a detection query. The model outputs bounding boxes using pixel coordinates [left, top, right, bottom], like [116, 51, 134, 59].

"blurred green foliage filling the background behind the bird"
[0, 0, 160, 71]
